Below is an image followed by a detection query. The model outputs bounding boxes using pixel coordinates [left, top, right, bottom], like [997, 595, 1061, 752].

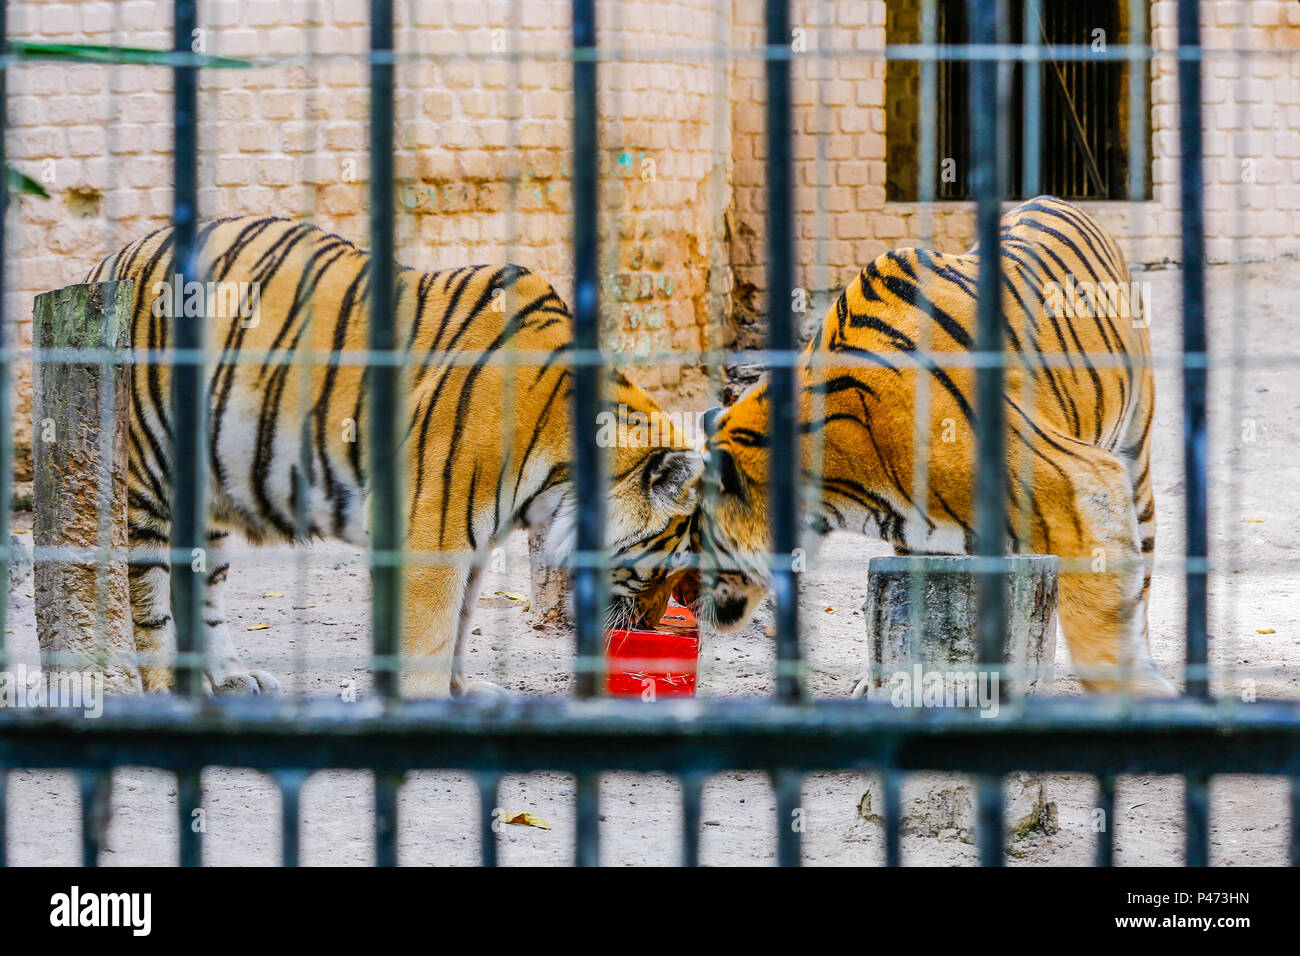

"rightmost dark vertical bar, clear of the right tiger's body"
[1178, 0, 1209, 697]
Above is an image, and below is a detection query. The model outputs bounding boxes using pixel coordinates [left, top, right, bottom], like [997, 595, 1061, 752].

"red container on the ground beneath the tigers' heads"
[605, 601, 699, 700]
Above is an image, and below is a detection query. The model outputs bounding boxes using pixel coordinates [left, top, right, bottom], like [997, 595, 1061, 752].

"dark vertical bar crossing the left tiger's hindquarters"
[169, 0, 208, 695]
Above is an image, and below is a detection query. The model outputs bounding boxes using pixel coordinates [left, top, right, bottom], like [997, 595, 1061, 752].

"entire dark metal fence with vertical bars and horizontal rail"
[0, 0, 1300, 865]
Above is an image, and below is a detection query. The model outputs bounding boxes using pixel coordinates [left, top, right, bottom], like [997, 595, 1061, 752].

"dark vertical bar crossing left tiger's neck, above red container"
[573, 0, 606, 697]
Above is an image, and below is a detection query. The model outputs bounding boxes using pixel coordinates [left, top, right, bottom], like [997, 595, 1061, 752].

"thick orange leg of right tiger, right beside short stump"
[1034, 438, 1173, 696]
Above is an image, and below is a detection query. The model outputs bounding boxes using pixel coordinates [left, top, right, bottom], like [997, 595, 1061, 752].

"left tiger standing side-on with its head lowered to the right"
[87, 216, 702, 697]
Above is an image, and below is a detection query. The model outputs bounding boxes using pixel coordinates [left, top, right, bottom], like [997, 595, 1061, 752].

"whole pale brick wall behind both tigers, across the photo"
[7, 0, 1300, 470]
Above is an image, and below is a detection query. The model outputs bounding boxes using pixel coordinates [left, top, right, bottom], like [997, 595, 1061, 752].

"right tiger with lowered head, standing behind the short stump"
[681, 196, 1173, 696]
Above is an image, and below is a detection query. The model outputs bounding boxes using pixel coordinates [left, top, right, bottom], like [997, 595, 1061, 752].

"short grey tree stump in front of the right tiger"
[854, 554, 1057, 853]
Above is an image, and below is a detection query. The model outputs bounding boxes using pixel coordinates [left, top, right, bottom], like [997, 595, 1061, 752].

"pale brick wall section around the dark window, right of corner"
[733, 0, 1300, 332]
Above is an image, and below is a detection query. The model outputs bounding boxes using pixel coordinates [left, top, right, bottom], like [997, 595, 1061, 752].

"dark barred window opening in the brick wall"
[885, 0, 1149, 200]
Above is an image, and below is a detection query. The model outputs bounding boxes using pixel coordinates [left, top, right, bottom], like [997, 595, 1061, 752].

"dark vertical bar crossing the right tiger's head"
[767, 0, 803, 702]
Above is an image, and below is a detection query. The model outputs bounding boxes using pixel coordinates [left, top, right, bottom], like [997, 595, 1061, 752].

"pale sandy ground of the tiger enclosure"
[9, 263, 1300, 865]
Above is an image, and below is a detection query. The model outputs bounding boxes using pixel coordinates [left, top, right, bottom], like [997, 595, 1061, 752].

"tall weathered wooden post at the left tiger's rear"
[33, 281, 142, 693]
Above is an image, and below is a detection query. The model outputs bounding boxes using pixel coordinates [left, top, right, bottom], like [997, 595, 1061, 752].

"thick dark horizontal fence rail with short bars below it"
[0, 697, 1300, 865]
